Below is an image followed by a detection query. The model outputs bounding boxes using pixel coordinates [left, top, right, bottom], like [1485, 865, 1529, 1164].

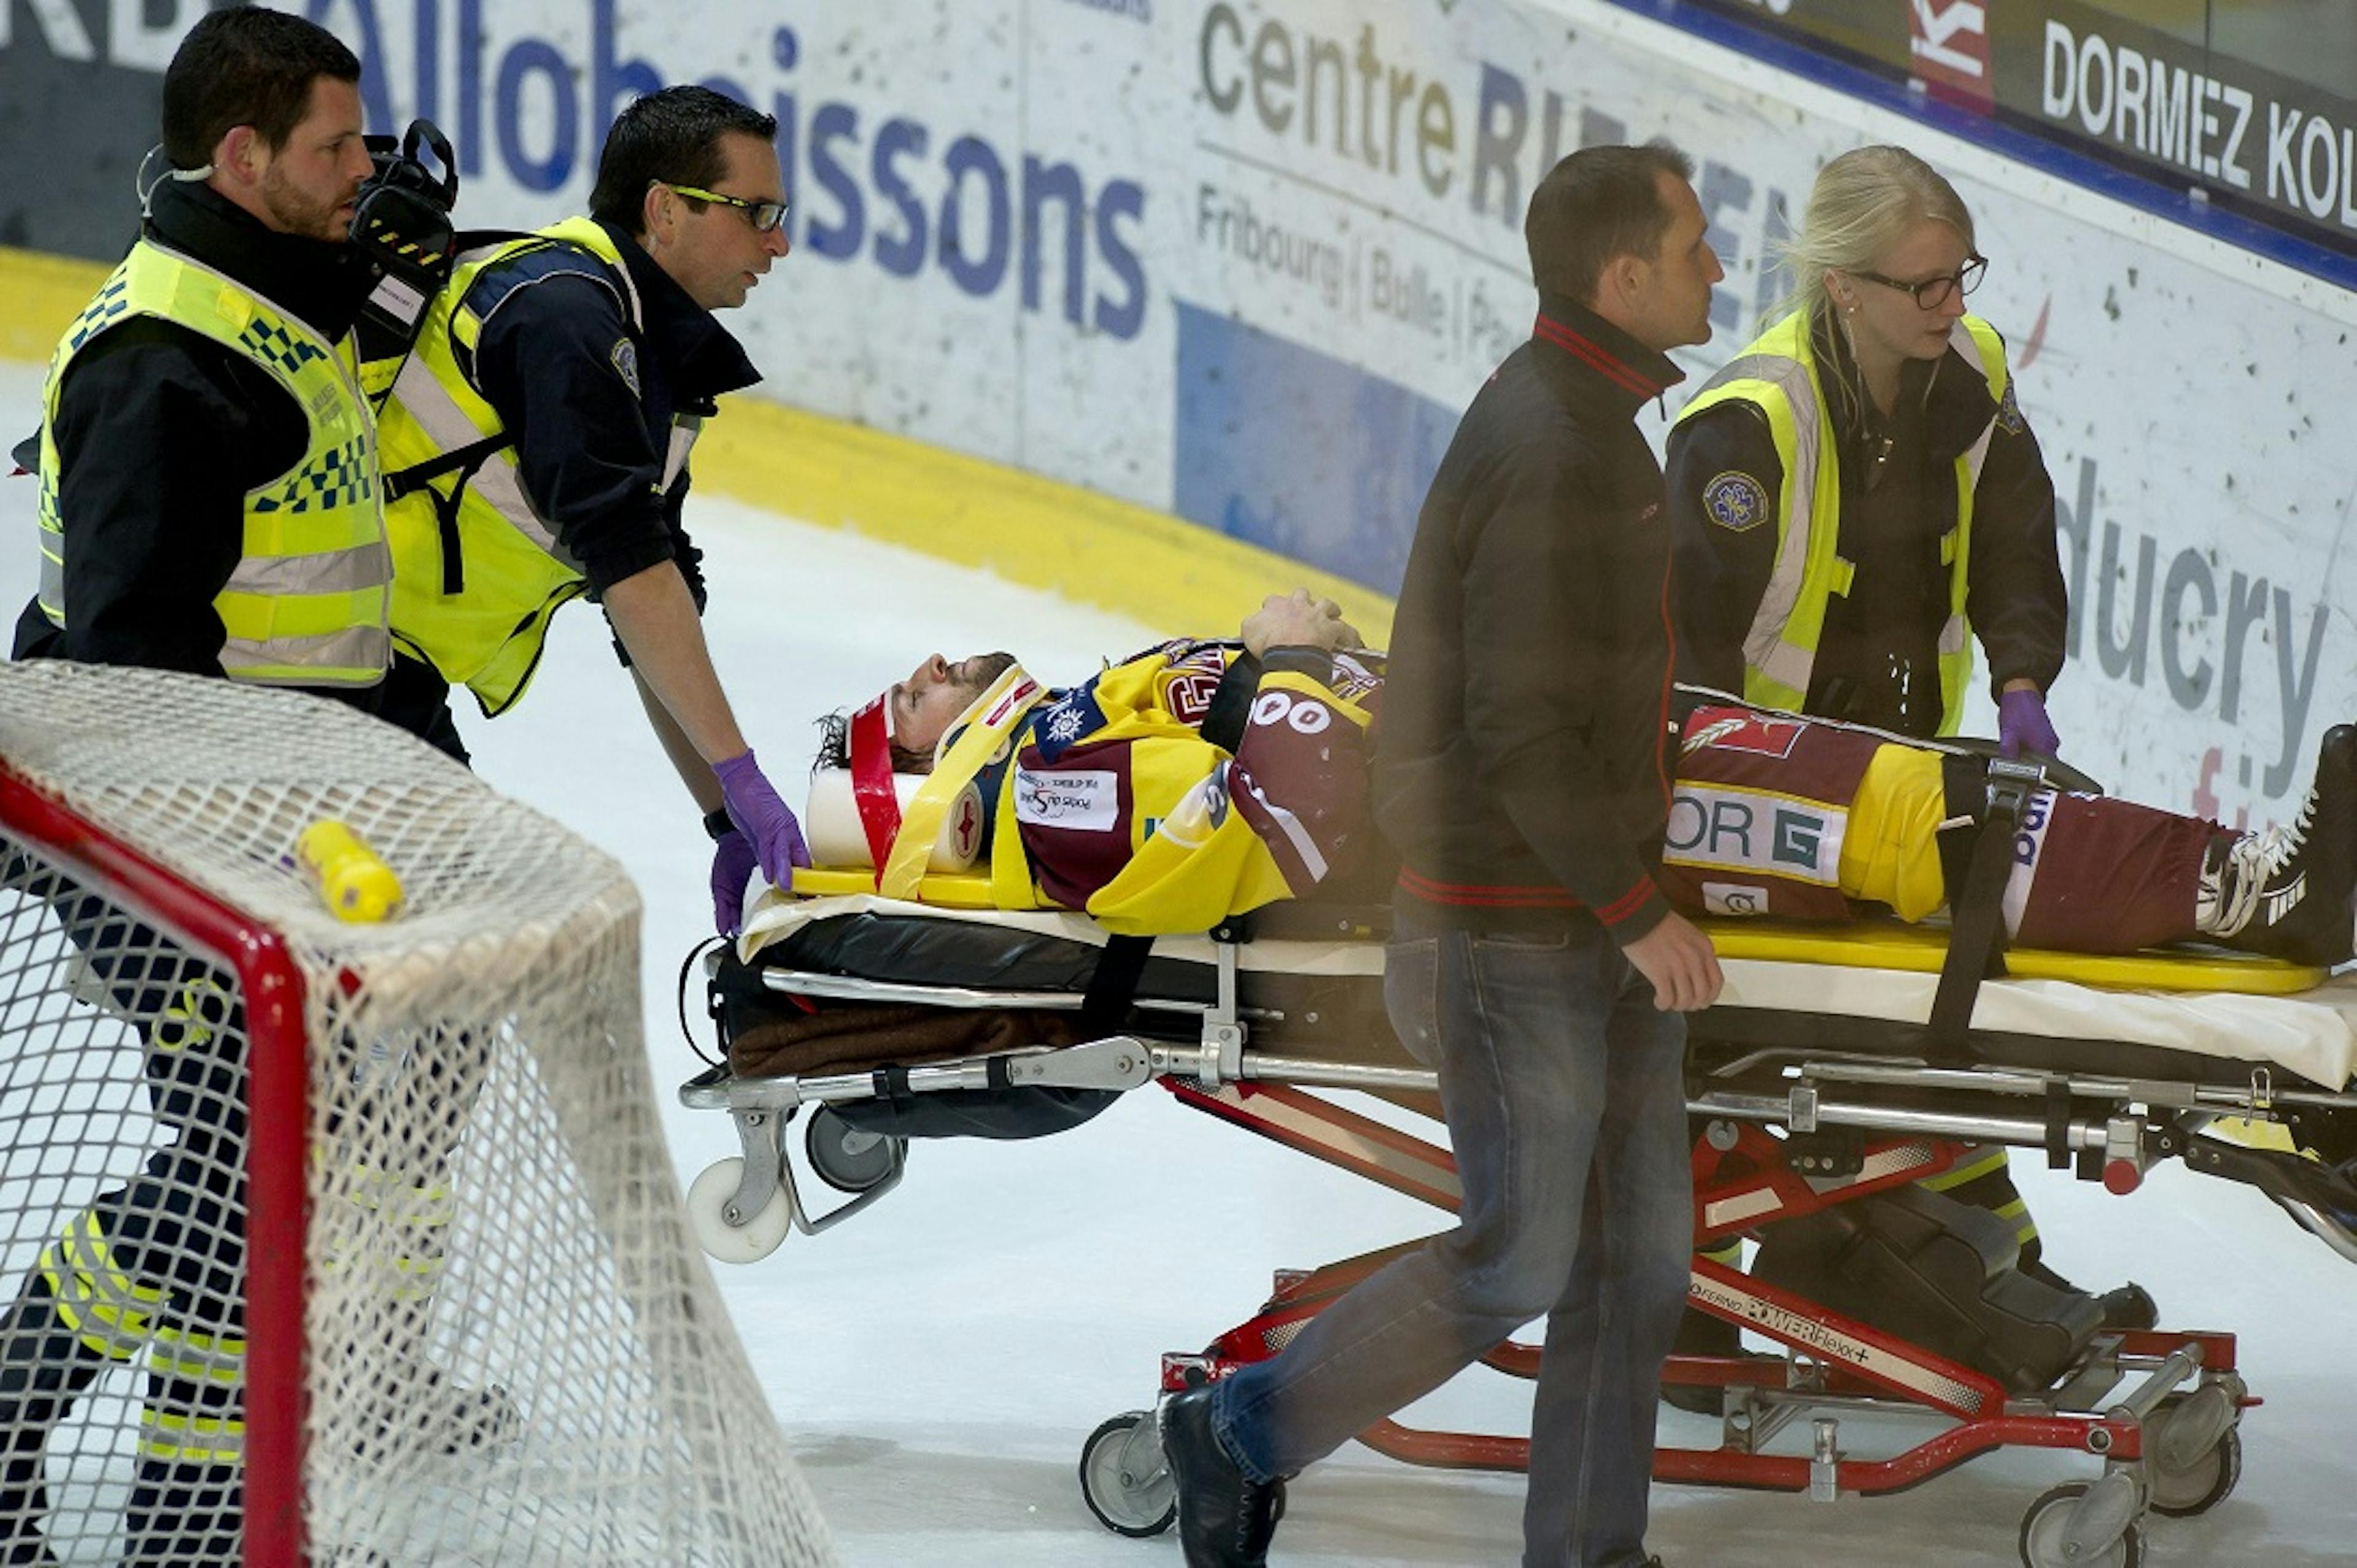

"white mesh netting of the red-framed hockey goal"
[0, 665, 832, 1568]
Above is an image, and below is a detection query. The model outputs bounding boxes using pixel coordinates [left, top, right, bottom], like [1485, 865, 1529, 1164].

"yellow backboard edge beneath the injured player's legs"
[1701, 919, 2326, 995]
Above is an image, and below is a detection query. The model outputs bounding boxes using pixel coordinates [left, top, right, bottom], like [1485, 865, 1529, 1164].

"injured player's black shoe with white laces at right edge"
[2194, 724, 2357, 964]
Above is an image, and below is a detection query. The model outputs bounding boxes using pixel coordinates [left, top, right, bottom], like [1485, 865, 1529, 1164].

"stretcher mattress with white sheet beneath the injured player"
[738, 894, 2357, 1089]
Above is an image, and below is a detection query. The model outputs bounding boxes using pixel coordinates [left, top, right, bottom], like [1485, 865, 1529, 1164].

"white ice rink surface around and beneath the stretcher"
[0, 363, 2357, 1568]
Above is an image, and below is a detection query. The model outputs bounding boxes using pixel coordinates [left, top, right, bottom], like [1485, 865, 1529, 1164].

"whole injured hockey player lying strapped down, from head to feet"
[801, 592, 2357, 964]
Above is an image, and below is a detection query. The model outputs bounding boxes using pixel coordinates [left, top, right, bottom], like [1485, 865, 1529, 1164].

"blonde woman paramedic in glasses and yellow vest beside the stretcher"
[1666, 146, 2111, 1358]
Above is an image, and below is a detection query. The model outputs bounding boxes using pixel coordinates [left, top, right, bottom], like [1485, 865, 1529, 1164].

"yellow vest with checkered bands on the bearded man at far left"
[37, 241, 393, 686]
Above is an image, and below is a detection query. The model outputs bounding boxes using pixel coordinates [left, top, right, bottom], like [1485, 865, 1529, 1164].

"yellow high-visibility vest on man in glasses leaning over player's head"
[379, 217, 698, 717]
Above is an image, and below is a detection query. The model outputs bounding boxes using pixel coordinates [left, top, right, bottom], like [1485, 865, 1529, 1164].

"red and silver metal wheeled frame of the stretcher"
[681, 910, 2357, 1568]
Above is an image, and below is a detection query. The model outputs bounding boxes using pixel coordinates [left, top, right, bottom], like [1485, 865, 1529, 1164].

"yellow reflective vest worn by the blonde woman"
[1678, 311, 2011, 736]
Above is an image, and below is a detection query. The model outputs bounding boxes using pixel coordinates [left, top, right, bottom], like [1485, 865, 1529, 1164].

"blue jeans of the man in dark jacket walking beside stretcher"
[1212, 910, 1695, 1568]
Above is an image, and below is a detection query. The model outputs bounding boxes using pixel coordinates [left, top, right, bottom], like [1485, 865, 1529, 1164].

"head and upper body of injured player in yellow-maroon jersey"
[813, 592, 1388, 933]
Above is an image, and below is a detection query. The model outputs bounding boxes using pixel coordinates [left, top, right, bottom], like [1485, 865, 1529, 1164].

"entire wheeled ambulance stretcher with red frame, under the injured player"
[679, 778, 2357, 1568]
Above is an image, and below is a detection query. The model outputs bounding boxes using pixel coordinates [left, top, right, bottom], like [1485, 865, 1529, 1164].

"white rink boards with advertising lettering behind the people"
[0, 0, 2357, 823]
